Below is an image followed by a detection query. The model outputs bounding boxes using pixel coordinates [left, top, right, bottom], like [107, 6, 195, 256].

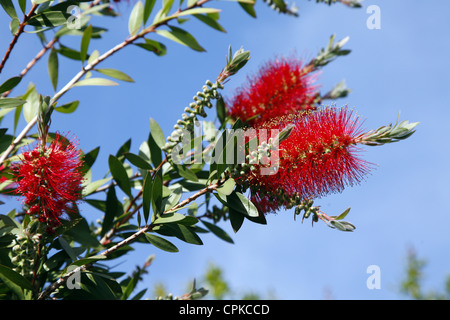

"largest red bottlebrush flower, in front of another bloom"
[238, 107, 370, 213]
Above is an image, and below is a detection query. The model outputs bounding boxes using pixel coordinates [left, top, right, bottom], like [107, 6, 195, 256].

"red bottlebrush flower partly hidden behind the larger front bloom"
[227, 59, 317, 126]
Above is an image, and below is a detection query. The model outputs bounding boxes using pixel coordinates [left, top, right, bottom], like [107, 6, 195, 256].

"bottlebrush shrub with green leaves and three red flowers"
[0, 0, 417, 300]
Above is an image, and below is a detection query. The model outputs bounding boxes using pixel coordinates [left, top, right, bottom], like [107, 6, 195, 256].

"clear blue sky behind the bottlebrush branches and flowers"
[0, 0, 450, 299]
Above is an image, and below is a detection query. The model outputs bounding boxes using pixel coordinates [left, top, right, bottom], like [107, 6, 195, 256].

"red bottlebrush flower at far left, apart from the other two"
[12, 135, 83, 227]
